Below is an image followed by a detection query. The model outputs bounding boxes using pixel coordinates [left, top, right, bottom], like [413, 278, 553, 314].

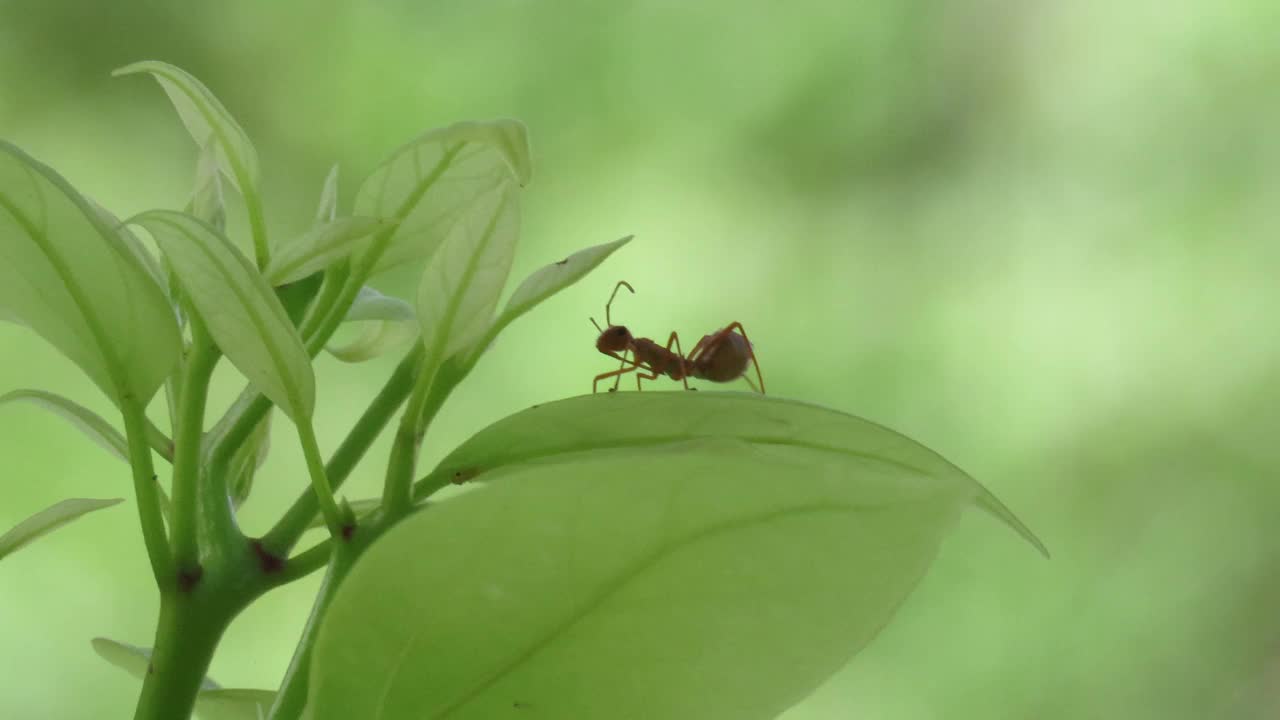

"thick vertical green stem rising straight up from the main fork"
[170, 322, 219, 573]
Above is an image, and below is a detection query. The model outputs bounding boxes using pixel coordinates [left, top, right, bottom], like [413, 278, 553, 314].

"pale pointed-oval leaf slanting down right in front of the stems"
[131, 210, 315, 420]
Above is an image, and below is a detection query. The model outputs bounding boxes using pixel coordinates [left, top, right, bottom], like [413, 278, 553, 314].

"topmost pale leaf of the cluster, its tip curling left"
[111, 60, 259, 196]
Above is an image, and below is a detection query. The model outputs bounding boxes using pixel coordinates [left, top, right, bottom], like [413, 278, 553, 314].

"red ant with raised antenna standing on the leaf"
[591, 281, 764, 395]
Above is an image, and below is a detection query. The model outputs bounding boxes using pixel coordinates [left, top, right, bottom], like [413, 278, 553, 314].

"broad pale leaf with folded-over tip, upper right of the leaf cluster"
[353, 120, 530, 273]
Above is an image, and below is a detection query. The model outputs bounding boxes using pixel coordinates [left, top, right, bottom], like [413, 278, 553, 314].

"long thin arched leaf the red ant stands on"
[416, 392, 1048, 555]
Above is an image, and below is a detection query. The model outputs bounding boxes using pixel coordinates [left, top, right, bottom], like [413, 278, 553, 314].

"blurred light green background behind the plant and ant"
[0, 0, 1280, 720]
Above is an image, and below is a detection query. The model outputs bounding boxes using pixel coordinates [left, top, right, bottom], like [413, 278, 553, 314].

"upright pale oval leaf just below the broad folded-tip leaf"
[416, 179, 520, 360]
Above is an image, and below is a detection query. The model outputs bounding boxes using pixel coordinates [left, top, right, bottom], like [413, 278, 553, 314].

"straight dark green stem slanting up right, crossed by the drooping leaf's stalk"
[262, 342, 425, 557]
